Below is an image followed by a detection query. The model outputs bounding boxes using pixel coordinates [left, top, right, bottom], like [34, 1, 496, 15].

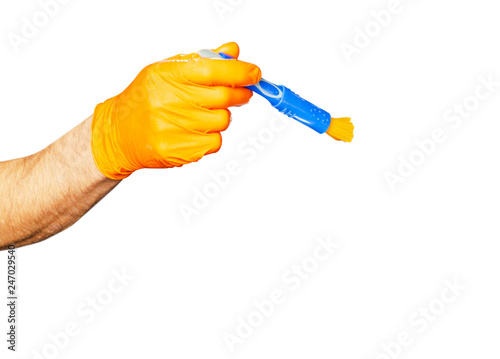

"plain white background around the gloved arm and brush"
[0, 0, 500, 359]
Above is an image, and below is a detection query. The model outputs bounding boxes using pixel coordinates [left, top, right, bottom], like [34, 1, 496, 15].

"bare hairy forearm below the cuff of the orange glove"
[0, 117, 120, 249]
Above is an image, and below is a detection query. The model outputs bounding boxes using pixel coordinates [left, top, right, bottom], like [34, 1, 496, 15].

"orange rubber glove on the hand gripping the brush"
[92, 42, 261, 180]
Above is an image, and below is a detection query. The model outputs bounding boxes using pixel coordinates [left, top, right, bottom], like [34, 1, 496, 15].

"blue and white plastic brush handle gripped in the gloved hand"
[198, 50, 332, 133]
